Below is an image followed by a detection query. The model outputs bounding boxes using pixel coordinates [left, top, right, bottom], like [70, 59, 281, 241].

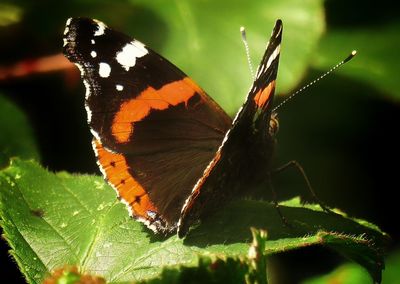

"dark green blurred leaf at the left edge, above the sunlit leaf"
[0, 94, 39, 164]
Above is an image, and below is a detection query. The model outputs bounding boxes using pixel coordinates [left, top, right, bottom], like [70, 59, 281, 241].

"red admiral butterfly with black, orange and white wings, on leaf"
[64, 18, 282, 237]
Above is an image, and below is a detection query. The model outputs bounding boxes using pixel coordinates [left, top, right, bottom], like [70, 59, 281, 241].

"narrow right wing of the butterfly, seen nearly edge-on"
[178, 20, 283, 237]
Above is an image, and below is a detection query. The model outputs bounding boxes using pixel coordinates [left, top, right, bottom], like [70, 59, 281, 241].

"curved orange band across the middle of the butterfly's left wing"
[111, 77, 203, 143]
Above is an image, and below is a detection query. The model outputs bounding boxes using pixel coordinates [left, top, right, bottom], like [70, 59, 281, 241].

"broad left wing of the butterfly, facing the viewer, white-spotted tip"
[64, 18, 231, 232]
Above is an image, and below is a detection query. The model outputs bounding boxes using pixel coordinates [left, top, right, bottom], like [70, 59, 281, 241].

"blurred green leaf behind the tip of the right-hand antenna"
[313, 21, 400, 100]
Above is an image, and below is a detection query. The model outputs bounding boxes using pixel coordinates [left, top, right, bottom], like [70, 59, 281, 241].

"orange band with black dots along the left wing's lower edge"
[93, 140, 157, 219]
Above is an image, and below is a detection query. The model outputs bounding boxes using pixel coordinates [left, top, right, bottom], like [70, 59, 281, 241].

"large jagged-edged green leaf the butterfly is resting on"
[0, 159, 387, 283]
